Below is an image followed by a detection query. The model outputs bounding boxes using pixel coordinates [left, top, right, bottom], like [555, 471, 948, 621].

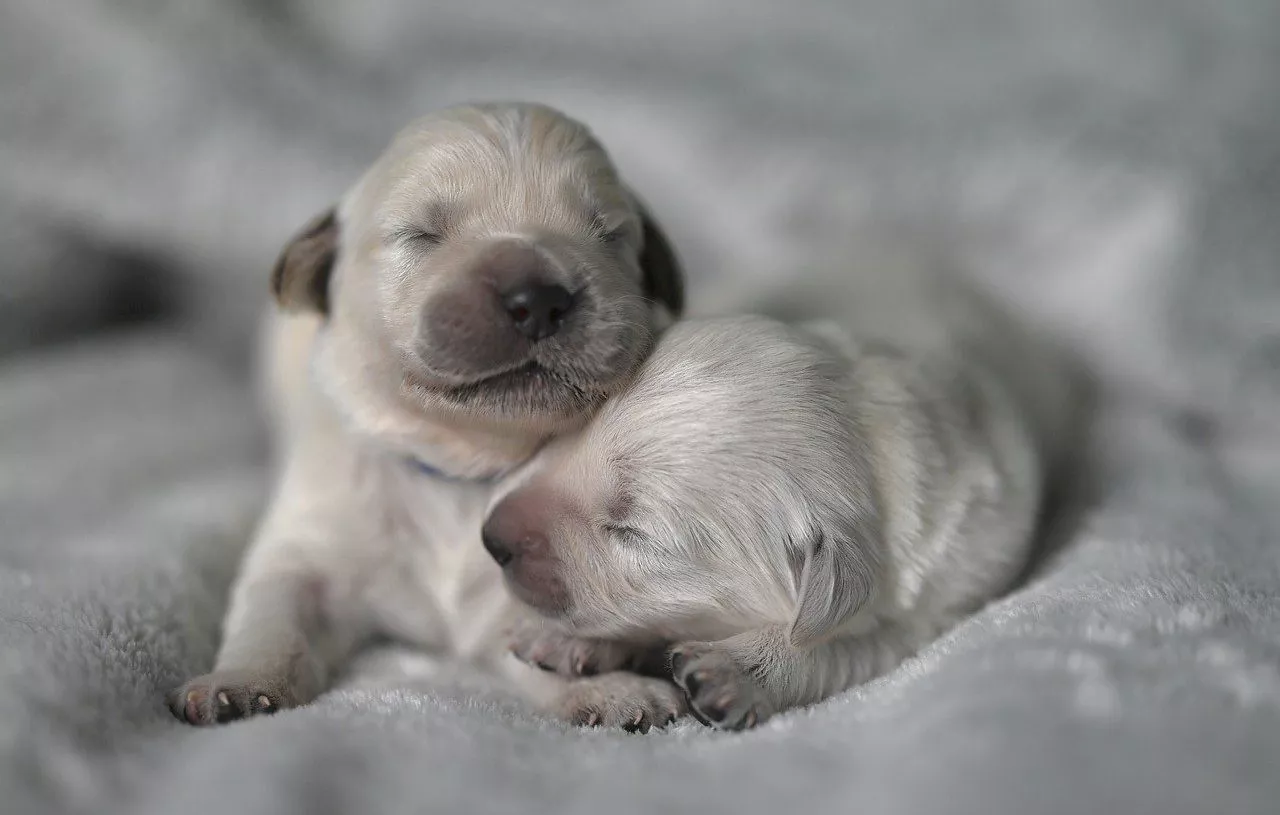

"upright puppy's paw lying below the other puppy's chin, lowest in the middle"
[556, 673, 685, 733]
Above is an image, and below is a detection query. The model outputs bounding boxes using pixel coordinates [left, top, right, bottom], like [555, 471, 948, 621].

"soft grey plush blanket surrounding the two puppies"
[0, 0, 1280, 815]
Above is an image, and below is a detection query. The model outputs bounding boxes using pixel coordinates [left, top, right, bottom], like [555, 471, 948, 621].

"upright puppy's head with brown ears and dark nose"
[271, 105, 682, 468]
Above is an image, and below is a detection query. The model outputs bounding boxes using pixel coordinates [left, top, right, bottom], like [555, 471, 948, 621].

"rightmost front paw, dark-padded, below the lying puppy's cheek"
[671, 642, 776, 731]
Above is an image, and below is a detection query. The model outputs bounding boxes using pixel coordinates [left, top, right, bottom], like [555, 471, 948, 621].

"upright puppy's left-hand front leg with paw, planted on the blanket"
[169, 445, 376, 724]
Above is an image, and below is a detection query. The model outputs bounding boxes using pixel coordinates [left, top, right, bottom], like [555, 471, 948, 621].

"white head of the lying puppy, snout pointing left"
[484, 317, 881, 646]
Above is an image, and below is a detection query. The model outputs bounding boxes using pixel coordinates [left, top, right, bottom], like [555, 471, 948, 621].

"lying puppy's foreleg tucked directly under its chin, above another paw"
[509, 618, 668, 678]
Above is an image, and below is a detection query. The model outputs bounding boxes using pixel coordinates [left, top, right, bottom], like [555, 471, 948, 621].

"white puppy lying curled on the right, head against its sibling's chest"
[483, 267, 1071, 729]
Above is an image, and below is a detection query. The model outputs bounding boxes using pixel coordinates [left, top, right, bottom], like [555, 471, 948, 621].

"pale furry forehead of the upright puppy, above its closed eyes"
[378, 105, 627, 219]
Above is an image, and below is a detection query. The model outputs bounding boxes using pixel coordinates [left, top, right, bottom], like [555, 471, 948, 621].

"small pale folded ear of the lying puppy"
[787, 528, 879, 649]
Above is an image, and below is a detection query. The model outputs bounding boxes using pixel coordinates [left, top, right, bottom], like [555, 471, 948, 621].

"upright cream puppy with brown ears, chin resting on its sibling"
[169, 104, 682, 727]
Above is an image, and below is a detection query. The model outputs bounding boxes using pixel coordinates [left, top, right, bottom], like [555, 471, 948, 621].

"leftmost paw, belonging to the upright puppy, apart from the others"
[165, 670, 300, 725]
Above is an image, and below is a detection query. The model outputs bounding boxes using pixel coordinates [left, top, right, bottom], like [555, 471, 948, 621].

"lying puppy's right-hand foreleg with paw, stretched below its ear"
[671, 627, 914, 731]
